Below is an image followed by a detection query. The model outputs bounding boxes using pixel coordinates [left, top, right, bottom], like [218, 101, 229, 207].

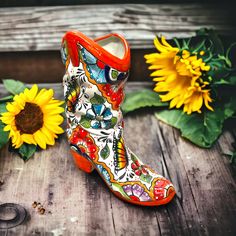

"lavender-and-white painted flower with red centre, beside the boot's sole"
[123, 184, 151, 202]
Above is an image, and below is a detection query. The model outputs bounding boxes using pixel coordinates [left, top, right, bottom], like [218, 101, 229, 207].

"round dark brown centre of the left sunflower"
[15, 102, 43, 134]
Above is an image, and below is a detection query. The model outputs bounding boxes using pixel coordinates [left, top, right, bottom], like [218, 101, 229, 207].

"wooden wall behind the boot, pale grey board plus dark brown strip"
[0, 4, 236, 82]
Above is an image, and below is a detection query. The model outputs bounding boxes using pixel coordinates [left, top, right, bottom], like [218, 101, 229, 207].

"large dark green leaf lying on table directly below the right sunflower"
[155, 106, 229, 148]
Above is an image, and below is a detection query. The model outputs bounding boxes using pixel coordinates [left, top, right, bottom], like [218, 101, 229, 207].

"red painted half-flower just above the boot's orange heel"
[69, 126, 98, 160]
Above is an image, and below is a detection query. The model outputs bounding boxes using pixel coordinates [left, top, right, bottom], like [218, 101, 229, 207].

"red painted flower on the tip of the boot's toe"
[153, 179, 173, 200]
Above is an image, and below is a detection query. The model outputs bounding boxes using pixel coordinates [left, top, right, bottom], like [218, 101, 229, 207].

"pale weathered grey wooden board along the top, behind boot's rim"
[0, 3, 236, 52]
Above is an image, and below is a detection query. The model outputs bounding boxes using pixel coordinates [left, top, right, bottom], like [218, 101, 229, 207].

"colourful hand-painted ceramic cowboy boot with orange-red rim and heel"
[61, 31, 175, 206]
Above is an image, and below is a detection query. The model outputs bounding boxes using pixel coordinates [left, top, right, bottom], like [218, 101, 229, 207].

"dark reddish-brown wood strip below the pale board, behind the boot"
[0, 49, 153, 83]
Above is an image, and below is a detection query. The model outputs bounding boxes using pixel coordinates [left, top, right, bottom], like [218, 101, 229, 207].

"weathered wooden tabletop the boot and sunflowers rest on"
[0, 83, 236, 236]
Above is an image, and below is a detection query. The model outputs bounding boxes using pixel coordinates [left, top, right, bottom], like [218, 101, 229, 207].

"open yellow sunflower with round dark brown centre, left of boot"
[0, 84, 64, 149]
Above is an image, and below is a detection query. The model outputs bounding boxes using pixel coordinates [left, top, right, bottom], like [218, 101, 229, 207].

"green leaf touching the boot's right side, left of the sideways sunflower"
[122, 89, 168, 113]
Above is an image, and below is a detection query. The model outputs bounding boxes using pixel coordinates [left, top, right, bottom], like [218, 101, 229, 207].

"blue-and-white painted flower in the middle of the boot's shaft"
[86, 104, 112, 129]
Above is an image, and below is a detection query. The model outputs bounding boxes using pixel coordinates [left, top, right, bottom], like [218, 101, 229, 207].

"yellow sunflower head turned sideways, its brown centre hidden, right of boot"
[145, 36, 213, 114]
